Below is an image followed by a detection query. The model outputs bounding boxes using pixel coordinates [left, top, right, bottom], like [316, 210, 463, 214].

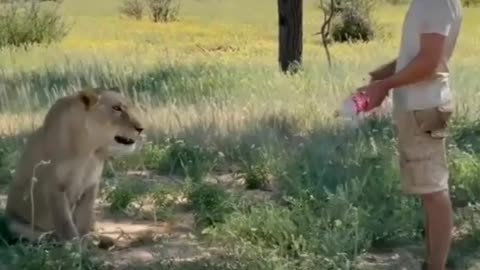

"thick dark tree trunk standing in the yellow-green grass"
[278, 0, 303, 72]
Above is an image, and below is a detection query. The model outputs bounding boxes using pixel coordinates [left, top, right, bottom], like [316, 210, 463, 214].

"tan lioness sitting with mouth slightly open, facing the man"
[1, 88, 143, 244]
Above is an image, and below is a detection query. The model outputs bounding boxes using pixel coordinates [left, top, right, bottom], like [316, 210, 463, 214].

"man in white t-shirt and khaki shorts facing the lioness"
[357, 0, 463, 270]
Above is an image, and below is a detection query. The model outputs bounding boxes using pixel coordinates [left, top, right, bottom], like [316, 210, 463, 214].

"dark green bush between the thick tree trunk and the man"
[332, 0, 375, 42]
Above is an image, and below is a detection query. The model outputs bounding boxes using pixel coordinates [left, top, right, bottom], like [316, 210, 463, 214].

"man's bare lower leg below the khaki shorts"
[422, 191, 453, 270]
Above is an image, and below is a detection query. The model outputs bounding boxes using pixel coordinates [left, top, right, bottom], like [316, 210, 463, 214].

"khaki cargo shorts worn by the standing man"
[393, 103, 453, 194]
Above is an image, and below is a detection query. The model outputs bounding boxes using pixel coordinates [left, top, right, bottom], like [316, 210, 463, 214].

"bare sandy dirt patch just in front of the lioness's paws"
[97, 213, 214, 269]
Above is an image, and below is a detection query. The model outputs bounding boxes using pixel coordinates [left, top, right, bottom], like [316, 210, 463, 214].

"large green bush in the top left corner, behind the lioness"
[0, 1, 68, 47]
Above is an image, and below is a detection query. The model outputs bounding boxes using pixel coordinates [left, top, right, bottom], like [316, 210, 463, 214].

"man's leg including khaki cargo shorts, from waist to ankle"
[396, 106, 453, 270]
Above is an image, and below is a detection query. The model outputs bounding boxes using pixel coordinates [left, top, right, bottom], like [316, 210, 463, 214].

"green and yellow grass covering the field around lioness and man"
[0, 0, 480, 270]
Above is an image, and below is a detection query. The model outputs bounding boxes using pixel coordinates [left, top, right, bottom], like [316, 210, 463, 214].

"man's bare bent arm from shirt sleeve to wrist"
[381, 33, 446, 89]
